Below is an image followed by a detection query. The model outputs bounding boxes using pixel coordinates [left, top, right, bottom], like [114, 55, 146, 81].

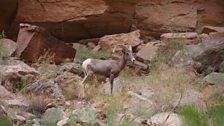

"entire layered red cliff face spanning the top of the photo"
[0, 0, 224, 42]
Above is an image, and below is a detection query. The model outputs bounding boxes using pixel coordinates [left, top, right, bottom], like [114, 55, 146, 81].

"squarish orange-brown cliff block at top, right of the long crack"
[136, 0, 197, 37]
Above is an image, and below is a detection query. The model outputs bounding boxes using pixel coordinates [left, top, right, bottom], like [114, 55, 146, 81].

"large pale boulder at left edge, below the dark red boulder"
[0, 59, 39, 92]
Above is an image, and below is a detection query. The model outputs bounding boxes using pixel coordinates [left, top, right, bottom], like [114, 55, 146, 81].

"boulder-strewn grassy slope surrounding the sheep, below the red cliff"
[0, 22, 224, 126]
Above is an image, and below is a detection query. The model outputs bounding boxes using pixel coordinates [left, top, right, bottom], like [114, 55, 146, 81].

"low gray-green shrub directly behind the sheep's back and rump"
[76, 46, 112, 62]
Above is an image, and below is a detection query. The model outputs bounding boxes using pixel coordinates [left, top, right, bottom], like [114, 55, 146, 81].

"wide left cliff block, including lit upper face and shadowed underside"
[13, 0, 137, 41]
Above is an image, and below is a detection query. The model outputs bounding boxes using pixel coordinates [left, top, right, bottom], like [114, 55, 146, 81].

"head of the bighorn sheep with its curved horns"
[113, 45, 135, 63]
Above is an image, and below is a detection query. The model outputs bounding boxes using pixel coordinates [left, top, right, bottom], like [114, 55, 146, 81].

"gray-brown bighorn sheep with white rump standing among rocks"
[81, 45, 135, 95]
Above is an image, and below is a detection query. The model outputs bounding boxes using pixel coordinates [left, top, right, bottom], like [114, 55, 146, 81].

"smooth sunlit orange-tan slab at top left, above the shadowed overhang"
[17, 0, 107, 22]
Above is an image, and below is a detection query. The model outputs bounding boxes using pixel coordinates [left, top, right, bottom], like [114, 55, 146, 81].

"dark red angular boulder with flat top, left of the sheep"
[16, 24, 76, 63]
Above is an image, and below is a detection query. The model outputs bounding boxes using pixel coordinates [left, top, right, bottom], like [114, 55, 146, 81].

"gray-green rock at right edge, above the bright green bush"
[203, 72, 224, 86]
